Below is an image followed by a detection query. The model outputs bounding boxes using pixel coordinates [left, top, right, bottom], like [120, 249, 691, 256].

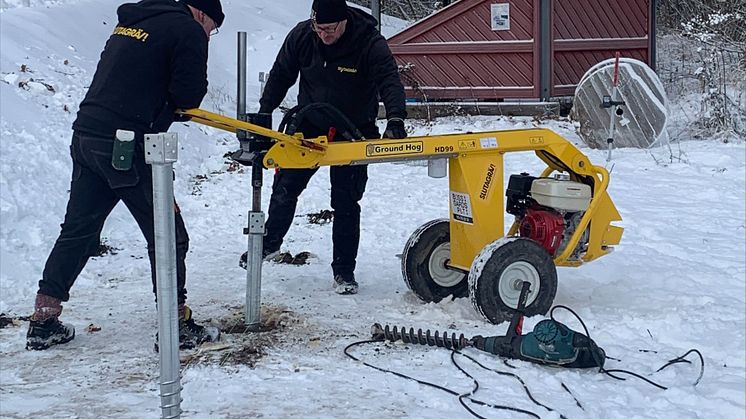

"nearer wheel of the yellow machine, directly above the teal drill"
[468, 237, 557, 324]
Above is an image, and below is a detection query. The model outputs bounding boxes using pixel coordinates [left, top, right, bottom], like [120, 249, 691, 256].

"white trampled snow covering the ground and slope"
[0, 0, 746, 418]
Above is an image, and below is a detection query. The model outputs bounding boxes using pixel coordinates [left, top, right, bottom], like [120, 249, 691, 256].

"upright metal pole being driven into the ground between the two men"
[236, 32, 264, 331]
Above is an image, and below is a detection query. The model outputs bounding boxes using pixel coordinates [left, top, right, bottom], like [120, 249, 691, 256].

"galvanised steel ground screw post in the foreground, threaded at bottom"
[145, 133, 181, 419]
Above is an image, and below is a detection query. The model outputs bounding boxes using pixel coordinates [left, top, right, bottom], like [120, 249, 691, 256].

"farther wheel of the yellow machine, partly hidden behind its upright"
[401, 219, 469, 303]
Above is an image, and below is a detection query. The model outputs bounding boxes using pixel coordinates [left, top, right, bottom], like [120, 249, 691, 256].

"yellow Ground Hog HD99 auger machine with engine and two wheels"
[181, 109, 623, 323]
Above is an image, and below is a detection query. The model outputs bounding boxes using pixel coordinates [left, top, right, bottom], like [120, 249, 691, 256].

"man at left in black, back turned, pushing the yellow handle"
[26, 0, 225, 349]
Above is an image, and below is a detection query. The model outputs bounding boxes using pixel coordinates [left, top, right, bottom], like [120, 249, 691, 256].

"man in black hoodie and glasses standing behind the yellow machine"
[253, 0, 407, 294]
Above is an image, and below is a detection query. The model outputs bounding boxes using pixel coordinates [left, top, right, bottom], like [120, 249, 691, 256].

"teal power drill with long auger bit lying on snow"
[371, 281, 606, 368]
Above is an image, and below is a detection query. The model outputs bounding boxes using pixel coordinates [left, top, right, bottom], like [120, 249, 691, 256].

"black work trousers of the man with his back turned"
[39, 131, 189, 304]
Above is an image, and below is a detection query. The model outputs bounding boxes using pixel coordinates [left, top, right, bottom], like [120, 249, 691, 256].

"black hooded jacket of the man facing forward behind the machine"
[259, 7, 407, 138]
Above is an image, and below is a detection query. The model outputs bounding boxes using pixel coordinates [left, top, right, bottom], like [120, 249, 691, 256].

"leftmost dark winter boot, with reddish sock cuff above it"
[26, 294, 75, 350]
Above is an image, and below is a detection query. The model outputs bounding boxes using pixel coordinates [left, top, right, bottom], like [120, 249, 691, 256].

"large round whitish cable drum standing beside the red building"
[573, 58, 668, 149]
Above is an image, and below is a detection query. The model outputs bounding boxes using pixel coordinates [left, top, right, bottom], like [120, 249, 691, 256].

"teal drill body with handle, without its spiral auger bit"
[469, 282, 606, 368]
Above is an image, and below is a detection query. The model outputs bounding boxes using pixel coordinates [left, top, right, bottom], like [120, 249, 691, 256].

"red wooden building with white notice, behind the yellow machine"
[389, 0, 656, 101]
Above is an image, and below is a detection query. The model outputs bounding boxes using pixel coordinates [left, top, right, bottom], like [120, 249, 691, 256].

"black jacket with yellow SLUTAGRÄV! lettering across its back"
[73, 0, 208, 139]
